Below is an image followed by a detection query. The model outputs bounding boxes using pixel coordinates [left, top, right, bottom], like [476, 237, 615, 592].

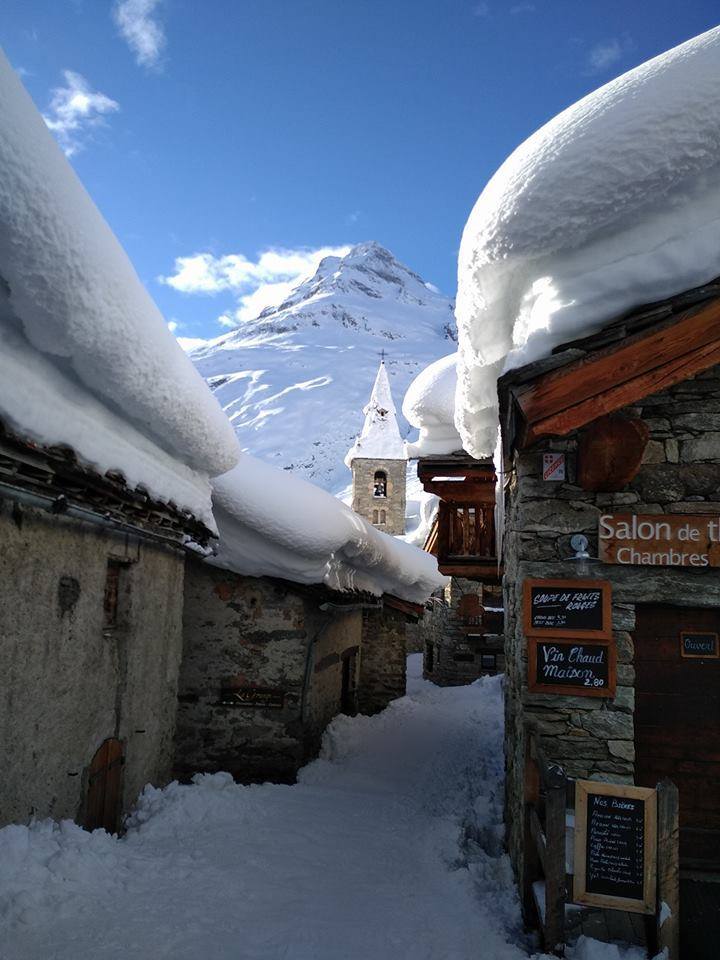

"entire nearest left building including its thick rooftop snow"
[0, 53, 240, 831]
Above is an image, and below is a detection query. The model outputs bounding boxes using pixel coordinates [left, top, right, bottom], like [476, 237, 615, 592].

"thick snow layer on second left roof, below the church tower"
[210, 454, 446, 603]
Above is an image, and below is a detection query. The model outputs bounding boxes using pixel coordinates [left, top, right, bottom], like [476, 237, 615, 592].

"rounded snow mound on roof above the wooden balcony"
[403, 353, 462, 457]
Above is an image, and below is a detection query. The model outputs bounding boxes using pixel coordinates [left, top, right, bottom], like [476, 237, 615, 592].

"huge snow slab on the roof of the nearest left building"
[0, 52, 239, 525]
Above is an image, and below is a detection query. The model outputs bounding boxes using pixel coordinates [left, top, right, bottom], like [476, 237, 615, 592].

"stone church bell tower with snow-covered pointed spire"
[345, 360, 407, 535]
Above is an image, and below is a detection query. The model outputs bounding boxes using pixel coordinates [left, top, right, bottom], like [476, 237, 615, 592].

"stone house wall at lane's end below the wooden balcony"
[420, 577, 505, 687]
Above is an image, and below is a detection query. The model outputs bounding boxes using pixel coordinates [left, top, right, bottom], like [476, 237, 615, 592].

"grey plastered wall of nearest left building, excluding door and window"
[0, 500, 184, 823]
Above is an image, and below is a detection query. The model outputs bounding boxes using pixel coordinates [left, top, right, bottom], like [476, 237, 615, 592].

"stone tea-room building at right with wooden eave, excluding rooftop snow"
[499, 283, 720, 955]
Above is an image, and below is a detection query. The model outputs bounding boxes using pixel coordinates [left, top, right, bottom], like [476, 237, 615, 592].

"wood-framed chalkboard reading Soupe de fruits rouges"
[524, 580, 612, 640]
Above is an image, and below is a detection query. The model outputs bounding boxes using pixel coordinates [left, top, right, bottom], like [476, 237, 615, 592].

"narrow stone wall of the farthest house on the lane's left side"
[358, 605, 407, 714]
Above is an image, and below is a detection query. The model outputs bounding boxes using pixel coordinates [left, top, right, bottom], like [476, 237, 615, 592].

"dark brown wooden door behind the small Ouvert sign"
[635, 606, 720, 869]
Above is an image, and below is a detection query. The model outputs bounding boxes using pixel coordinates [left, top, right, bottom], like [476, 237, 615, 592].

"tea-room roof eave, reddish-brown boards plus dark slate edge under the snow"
[498, 281, 720, 456]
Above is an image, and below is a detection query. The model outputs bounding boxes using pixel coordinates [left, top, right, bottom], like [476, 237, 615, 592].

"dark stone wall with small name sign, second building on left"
[176, 561, 362, 782]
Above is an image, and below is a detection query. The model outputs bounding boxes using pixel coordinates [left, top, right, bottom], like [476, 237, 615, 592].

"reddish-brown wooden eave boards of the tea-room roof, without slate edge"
[510, 299, 720, 449]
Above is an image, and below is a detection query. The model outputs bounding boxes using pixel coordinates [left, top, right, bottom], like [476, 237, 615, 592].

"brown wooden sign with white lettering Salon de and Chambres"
[598, 513, 720, 567]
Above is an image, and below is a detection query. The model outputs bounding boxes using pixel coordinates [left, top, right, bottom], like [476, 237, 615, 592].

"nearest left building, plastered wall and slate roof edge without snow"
[0, 431, 208, 832]
